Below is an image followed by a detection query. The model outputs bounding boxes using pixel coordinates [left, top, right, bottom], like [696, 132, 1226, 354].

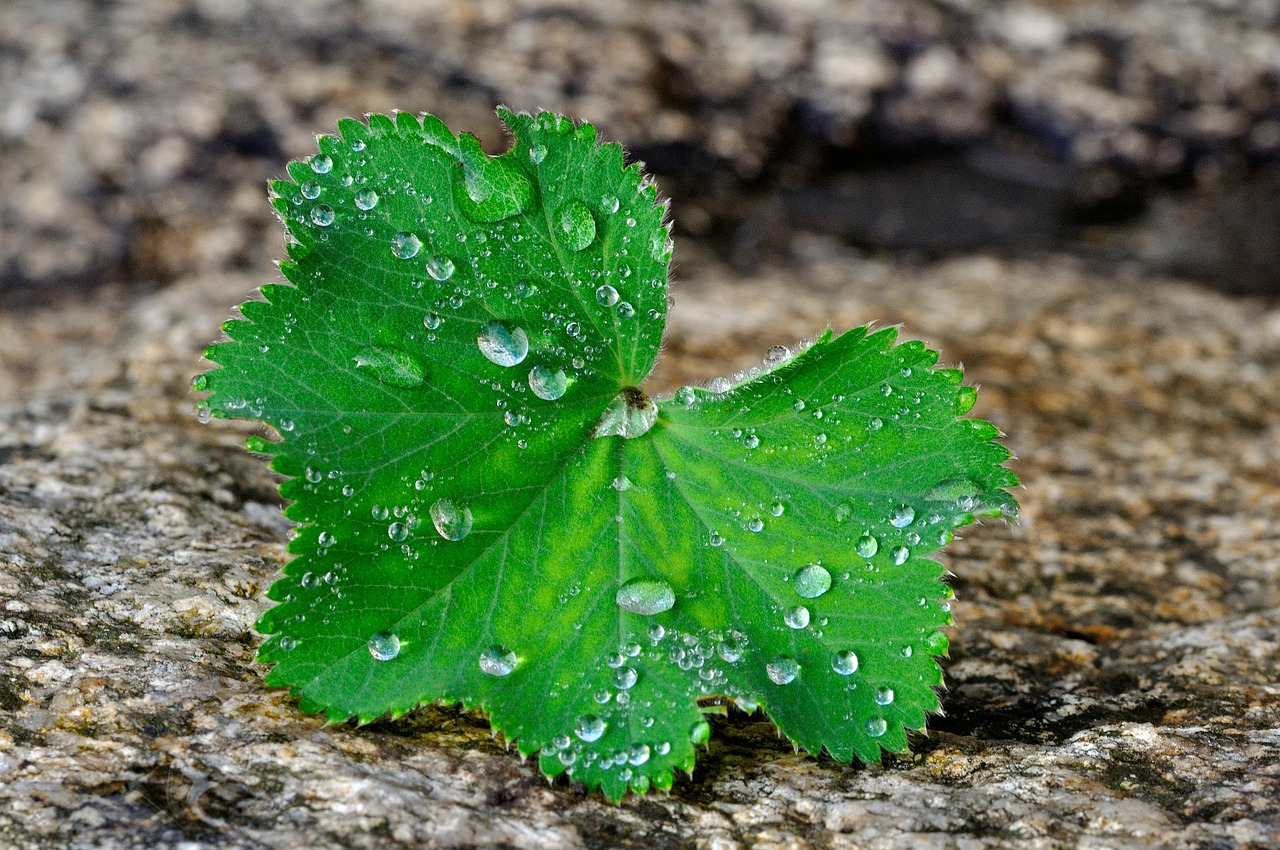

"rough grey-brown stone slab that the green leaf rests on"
[0, 239, 1280, 850]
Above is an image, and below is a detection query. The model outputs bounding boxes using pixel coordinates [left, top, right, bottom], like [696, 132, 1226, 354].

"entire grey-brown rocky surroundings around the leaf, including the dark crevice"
[0, 0, 1280, 850]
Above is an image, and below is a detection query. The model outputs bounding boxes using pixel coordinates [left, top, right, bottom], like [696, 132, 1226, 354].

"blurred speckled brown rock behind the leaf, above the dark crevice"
[0, 0, 1280, 293]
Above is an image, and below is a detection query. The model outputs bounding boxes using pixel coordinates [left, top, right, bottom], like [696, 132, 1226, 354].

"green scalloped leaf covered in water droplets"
[196, 111, 1016, 799]
